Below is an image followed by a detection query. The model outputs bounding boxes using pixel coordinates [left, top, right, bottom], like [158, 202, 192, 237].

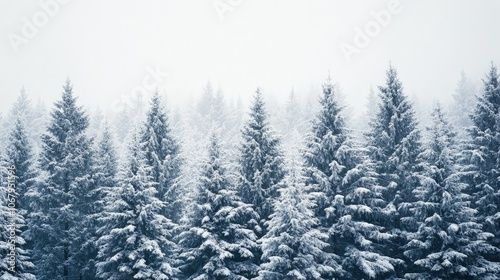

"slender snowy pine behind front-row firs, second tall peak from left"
[141, 92, 182, 222]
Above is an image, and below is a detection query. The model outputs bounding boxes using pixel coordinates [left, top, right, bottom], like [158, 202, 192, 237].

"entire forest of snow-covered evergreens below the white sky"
[0, 64, 500, 280]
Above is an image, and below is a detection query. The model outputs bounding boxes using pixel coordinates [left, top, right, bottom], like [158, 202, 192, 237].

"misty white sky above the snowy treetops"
[0, 0, 500, 115]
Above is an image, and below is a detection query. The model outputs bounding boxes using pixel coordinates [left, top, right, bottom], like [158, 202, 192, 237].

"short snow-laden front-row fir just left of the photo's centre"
[180, 134, 258, 279]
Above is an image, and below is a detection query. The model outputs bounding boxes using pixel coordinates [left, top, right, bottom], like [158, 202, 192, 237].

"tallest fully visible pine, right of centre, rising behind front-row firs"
[367, 66, 421, 202]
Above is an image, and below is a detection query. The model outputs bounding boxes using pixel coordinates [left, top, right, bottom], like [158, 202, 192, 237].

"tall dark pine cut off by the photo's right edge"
[465, 65, 500, 262]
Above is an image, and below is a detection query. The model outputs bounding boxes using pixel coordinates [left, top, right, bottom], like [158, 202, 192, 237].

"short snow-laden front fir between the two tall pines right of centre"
[329, 158, 404, 279]
